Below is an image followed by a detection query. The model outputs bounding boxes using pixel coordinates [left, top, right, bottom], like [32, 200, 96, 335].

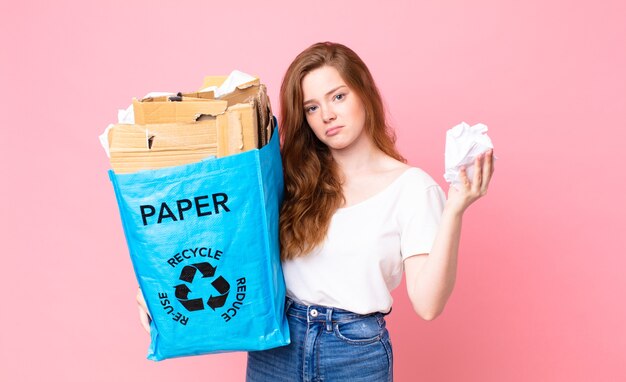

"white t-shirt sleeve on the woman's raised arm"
[400, 184, 446, 260]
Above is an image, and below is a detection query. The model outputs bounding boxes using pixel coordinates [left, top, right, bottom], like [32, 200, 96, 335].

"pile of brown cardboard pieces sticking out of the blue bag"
[109, 83, 273, 173]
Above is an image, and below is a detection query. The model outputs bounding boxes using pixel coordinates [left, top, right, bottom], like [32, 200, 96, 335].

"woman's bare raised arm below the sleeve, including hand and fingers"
[404, 148, 494, 320]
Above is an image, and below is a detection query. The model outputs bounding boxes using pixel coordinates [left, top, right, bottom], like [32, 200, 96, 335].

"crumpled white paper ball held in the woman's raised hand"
[443, 122, 497, 188]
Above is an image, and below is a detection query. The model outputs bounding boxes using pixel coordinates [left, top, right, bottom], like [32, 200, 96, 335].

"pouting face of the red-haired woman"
[302, 66, 368, 150]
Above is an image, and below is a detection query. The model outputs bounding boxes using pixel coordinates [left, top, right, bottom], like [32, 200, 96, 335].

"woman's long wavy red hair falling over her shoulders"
[279, 42, 406, 260]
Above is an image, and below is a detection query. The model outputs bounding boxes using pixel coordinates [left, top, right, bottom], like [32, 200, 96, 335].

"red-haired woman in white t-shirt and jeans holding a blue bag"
[138, 42, 493, 382]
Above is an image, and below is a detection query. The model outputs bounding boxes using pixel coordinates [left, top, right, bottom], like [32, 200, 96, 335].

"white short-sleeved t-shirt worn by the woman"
[282, 167, 446, 314]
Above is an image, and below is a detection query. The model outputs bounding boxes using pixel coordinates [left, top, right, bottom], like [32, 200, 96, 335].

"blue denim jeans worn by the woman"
[246, 298, 393, 382]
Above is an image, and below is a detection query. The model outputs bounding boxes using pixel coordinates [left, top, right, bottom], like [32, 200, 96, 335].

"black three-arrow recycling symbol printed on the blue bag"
[174, 263, 230, 312]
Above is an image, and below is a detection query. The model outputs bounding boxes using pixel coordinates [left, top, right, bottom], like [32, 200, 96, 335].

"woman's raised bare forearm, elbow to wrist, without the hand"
[410, 207, 462, 320]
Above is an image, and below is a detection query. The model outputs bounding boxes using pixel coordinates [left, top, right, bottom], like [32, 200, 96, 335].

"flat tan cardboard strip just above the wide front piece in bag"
[133, 99, 228, 125]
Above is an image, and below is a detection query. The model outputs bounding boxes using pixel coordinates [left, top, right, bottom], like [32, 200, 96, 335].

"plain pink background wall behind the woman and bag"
[0, 0, 626, 381]
